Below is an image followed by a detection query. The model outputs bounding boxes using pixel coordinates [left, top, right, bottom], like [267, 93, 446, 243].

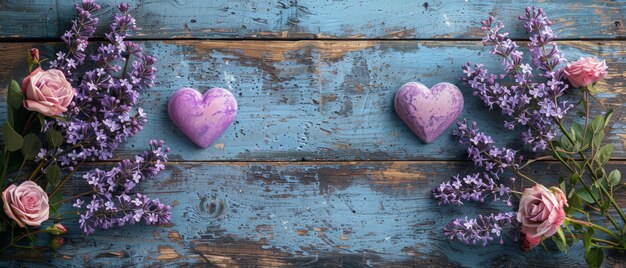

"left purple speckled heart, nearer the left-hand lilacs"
[167, 88, 237, 148]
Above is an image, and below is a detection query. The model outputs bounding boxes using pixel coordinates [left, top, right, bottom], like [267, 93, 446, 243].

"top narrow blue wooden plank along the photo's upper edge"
[0, 0, 626, 39]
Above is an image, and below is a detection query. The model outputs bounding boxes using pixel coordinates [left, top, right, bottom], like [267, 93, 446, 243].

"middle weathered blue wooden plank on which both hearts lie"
[0, 41, 626, 161]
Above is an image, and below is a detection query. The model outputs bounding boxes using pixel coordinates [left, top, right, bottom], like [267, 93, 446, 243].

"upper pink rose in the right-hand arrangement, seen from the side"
[563, 57, 608, 87]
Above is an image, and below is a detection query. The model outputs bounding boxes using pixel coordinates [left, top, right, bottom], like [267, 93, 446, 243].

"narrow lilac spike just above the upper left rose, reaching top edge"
[50, 0, 100, 81]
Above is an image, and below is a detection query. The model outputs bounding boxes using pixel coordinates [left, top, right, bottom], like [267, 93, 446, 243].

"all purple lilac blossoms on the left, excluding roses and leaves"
[37, 0, 170, 234]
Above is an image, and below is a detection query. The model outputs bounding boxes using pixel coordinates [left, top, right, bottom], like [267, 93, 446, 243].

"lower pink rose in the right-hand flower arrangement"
[517, 184, 567, 249]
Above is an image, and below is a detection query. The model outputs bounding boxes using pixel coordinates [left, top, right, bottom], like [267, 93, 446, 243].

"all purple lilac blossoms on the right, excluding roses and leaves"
[432, 8, 572, 245]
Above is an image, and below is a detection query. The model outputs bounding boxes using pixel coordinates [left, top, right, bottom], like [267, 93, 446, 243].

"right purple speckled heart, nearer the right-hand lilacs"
[394, 82, 463, 143]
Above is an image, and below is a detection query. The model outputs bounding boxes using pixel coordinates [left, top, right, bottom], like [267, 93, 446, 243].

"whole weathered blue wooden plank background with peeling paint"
[0, 0, 626, 267]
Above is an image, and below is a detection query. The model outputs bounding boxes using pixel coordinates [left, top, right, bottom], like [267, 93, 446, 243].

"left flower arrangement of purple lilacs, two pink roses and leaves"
[0, 0, 170, 251]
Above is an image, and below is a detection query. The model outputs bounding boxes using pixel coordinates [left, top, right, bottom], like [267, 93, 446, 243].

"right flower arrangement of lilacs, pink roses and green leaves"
[432, 7, 626, 267]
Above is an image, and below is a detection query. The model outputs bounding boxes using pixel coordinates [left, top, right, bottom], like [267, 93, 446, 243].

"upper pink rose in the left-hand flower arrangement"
[22, 68, 76, 116]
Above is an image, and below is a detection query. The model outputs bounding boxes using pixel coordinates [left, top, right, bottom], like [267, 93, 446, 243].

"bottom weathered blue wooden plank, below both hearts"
[0, 161, 626, 267]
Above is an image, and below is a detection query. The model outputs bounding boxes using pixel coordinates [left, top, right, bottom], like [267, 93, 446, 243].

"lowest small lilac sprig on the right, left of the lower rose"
[443, 212, 519, 246]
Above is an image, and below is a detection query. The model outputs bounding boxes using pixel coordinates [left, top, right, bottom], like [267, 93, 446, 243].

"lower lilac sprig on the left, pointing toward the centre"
[74, 140, 170, 234]
